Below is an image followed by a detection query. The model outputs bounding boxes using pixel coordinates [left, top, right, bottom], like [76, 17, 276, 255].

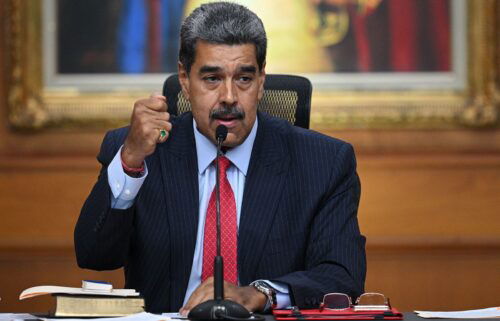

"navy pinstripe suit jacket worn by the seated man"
[75, 113, 366, 312]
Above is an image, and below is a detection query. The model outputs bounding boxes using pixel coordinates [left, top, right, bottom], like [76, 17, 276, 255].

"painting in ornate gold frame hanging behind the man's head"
[6, 0, 500, 130]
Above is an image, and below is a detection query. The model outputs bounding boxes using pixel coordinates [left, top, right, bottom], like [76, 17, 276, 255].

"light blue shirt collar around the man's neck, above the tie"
[193, 118, 258, 176]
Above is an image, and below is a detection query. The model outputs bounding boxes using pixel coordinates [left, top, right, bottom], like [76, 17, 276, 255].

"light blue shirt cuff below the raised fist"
[107, 146, 148, 209]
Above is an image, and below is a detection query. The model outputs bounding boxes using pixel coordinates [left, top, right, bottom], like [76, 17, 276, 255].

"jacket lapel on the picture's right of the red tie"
[238, 114, 289, 284]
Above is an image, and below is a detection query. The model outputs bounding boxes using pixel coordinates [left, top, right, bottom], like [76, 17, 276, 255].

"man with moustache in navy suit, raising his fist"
[75, 2, 366, 314]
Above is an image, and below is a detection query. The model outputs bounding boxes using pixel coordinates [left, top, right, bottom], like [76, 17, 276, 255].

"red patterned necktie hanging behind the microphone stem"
[201, 156, 238, 284]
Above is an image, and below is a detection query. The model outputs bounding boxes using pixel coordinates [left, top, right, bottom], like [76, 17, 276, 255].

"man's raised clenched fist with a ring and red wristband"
[121, 94, 172, 168]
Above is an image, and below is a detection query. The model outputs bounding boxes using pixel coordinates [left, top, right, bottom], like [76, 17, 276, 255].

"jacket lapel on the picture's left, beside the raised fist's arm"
[159, 114, 199, 307]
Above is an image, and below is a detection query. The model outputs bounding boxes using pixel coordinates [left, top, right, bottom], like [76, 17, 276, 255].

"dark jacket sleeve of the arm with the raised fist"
[74, 130, 135, 270]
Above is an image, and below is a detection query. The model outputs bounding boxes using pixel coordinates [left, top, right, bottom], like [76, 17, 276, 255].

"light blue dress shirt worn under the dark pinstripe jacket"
[108, 119, 290, 308]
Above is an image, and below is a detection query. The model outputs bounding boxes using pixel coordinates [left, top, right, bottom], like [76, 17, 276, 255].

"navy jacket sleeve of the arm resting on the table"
[273, 144, 366, 307]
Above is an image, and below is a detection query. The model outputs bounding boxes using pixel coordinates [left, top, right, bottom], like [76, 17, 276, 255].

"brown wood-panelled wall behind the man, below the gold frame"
[0, 5, 500, 312]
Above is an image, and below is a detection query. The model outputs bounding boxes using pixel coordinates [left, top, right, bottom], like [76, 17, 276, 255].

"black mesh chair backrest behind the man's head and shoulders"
[163, 74, 312, 128]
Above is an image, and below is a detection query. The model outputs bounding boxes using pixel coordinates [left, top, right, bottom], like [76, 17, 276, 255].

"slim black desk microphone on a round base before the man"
[188, 125, 252, 320]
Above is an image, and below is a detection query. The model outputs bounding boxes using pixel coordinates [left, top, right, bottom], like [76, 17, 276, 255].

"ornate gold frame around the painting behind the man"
[5, 0, 500, 130]
